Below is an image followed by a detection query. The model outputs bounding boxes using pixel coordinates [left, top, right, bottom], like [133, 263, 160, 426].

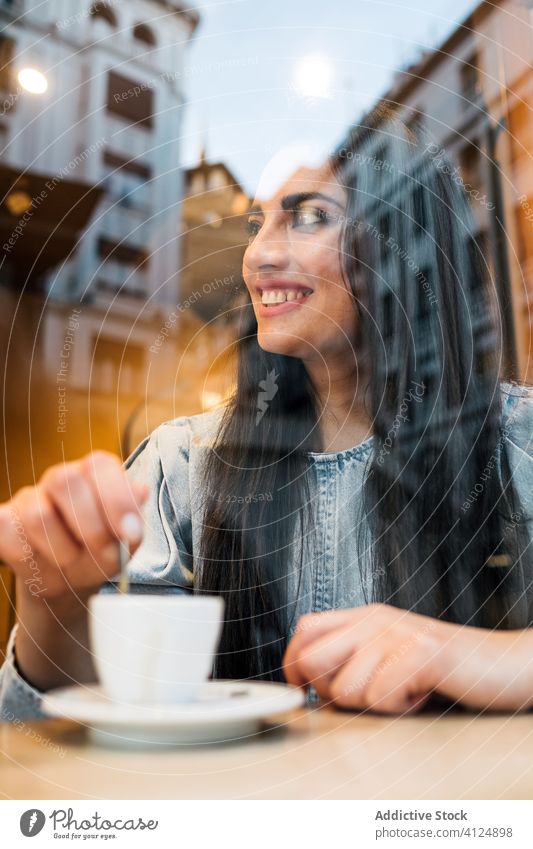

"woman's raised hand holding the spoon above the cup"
[0, 451, 148, 604]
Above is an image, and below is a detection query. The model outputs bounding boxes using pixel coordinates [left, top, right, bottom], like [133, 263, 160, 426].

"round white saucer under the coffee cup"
[42, 681, 304, 747]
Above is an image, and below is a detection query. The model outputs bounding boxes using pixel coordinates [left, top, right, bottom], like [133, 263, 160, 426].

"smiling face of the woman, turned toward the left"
[243, 167, 356, 360]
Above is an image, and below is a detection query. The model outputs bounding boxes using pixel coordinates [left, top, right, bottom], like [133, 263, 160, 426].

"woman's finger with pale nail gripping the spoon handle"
[82, 451, 147, 544]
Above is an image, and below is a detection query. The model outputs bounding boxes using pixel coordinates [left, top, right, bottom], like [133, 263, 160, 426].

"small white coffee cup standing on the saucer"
[89, 593, 224, 704]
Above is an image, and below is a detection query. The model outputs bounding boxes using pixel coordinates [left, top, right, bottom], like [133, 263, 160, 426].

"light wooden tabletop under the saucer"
[0, 707, 533, 800]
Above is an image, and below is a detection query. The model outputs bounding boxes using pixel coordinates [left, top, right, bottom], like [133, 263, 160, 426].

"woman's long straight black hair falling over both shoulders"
[195, 111, 531, 680]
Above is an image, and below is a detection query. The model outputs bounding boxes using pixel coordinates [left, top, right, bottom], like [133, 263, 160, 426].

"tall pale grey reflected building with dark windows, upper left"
[0, 0, 199, 313]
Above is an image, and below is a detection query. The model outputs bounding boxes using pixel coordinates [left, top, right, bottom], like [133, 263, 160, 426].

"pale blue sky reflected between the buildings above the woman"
[182, 0, 477, 195]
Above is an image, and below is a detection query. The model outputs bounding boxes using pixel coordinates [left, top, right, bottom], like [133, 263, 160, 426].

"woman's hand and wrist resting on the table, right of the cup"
[283, 604, 533, 713]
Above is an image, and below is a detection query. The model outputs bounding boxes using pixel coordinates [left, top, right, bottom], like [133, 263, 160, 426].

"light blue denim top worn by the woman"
[0, 383, 533, 720]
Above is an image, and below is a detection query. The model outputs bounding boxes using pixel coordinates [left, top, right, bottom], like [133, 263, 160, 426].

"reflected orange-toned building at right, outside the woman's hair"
[340, 0, 533, 381]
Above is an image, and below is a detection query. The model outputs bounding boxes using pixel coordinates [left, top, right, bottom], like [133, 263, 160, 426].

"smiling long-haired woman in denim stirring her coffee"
[0, 115, 533, 716]
